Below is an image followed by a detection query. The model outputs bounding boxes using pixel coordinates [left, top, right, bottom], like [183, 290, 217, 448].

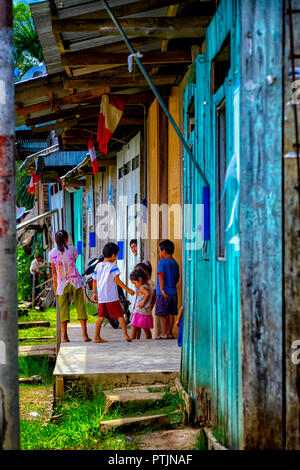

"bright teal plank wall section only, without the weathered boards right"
[181, 1, 242, 448]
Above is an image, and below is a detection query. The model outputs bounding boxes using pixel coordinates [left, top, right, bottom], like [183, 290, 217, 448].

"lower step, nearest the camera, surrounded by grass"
[100, 414, 170, 432]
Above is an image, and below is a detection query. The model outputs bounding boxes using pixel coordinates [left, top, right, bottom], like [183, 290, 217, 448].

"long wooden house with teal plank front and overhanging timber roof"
[15, 0, 300, 449]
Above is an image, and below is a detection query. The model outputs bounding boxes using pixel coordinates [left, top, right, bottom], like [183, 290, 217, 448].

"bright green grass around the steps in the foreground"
[20, 385, 182, 450]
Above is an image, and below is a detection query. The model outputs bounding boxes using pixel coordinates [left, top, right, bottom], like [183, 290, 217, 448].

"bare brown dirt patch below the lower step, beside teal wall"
[138, 426, 199, 450]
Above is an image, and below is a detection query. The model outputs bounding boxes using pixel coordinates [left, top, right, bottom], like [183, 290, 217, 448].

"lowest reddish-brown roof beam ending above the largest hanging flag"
[16, 87, 110, 116]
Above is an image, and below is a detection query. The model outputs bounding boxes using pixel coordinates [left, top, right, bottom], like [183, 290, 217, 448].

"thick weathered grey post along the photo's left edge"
[0, 0, 19, 448]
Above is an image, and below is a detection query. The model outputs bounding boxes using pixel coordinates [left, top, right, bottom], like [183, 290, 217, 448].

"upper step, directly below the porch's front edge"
[104, 384, 174, 408]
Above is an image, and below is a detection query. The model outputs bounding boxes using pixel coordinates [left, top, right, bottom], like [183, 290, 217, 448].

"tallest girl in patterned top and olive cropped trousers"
[48, 230, 91, 343]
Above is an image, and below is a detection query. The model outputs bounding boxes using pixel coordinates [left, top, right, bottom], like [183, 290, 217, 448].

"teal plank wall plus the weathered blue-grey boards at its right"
[181, 0, 285, 449]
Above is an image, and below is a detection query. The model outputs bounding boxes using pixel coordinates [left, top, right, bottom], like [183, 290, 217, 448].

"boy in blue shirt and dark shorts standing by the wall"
[155, 240, 180, 339]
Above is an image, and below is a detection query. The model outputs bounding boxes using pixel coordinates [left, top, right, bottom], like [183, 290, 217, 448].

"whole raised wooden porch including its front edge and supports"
[53, 324, 181, 397]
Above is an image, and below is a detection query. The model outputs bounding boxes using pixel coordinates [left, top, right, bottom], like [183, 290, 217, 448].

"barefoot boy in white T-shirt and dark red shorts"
[93, 242, 134, 343]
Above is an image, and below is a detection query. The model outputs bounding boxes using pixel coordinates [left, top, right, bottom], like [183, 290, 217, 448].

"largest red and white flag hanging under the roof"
[97, 95, 125, 154]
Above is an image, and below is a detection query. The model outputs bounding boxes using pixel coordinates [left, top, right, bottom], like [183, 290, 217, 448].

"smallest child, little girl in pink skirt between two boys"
[130, 269, 153, 339]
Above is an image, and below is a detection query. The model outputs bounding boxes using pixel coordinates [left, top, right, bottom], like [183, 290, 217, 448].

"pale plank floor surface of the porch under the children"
[53, 324, 181, 386]
